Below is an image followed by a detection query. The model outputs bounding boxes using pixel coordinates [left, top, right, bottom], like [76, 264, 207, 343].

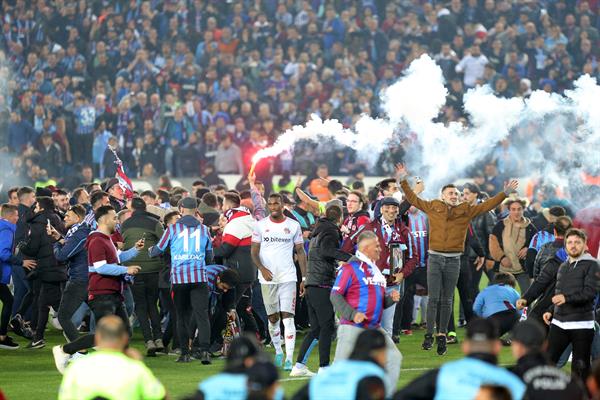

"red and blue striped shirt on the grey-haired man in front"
[331, 260, 385, 328]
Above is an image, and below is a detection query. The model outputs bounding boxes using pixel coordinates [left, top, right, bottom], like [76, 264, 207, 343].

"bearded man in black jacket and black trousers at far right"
[543, 229, 598, 379]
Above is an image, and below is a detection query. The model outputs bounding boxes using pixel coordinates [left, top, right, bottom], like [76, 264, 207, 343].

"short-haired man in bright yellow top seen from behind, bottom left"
[58, 315, 167, 400]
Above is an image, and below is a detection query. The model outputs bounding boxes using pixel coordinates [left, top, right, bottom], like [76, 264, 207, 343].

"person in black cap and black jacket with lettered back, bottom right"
[511, 319, 586, 400]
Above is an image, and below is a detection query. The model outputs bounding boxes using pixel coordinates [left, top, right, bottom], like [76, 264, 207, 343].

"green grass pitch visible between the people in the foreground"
[0, 327, 512, 400]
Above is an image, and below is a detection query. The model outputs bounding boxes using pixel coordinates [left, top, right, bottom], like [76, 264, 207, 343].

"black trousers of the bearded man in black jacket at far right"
[548, 325, 594, 382]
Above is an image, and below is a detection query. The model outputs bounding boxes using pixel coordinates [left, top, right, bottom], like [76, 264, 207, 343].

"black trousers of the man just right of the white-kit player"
[296, 286, 335, 367]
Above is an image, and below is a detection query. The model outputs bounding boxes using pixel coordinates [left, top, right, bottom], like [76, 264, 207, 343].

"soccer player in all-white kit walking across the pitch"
[252, 193, 306, 371]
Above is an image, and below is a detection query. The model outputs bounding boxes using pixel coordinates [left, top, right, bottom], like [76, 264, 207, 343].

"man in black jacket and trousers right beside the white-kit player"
[290, 206, 351, 376]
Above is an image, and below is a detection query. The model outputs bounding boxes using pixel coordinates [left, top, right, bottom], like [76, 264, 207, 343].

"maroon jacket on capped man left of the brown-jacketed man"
[364, 219, 419, 284]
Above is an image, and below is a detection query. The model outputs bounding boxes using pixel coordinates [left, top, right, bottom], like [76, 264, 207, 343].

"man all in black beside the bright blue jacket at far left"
[21, 197, 67, 349]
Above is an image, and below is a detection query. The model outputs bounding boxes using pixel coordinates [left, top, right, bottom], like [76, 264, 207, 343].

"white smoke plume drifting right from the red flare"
[254, 55, 600, 206]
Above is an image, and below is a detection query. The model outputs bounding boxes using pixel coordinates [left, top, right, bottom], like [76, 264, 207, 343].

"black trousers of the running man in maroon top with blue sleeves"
[63, 293, 131, 354]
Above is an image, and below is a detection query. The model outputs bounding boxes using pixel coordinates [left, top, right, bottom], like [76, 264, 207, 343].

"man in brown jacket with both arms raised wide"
[397, 167, 518, 355]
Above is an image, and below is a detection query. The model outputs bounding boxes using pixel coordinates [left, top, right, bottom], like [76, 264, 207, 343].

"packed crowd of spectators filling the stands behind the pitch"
[0, 0, 599, 187]
